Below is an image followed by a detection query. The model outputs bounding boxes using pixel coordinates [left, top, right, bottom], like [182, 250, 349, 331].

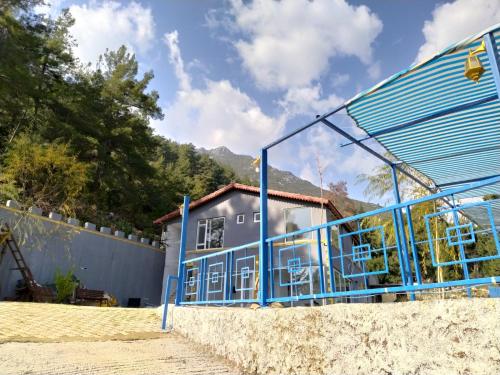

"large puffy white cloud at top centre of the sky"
[225, 0, 382, 90]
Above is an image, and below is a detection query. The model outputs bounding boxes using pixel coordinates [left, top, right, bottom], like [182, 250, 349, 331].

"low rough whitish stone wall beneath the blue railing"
[163, 299, 500, 375]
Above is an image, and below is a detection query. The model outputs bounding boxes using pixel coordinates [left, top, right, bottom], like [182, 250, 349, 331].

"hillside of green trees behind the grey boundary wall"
[0, 0, 234, 232]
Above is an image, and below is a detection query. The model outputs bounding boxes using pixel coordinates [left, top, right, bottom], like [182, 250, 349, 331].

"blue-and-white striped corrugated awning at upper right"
[346, 24, 500, 209]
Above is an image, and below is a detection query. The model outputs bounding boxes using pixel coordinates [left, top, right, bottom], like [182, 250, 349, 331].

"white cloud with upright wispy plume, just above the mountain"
[153, 31, 286, 155]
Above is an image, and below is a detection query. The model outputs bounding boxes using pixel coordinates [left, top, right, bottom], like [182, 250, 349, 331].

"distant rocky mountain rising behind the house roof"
[198, 146, 379, 215]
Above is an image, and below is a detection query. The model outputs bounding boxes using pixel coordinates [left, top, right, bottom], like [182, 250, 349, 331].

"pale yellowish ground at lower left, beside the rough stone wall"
[0, 302, 239, 375]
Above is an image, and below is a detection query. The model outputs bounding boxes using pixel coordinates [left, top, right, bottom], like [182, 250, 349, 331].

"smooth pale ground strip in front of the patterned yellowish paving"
[0, 334, 238, 375]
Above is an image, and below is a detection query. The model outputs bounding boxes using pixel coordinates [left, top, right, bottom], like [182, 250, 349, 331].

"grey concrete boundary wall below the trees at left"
[0, 207, 165, 306]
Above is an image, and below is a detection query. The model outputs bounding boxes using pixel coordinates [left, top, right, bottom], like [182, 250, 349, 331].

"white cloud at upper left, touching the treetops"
[69, 0, 155, 63]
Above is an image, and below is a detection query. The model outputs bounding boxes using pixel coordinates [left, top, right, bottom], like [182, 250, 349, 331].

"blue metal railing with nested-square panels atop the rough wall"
[163, 177, 500, 314]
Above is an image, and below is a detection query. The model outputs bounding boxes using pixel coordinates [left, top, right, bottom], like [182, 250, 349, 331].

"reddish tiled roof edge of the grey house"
[154, 182, 342, 224]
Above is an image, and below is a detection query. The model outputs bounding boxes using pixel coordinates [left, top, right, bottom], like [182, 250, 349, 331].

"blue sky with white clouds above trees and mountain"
[41, 0, 500, 204]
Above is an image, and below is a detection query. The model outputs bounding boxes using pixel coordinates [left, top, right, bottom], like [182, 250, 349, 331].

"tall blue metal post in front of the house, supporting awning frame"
[259, 148, 268, 306]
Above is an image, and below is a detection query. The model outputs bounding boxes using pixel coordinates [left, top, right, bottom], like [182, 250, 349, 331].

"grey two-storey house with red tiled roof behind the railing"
[155, 183, 376, 306]
